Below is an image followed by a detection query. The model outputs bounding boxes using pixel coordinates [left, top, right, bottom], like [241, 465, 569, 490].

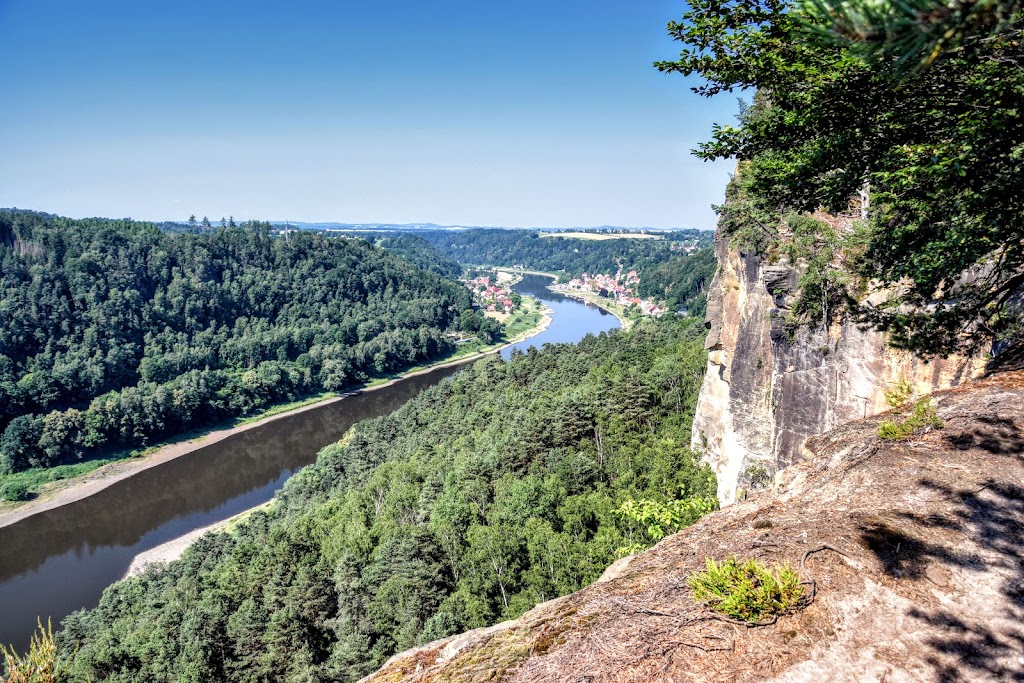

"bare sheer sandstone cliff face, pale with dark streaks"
[692, 230, 984, 505]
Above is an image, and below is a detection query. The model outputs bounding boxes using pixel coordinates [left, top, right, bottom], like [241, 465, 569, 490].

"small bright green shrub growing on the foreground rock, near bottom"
[689, 557, 804, 624]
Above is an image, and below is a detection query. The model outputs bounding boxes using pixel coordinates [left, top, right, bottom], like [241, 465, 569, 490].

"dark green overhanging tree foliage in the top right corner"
[656, 0, 1024, 354]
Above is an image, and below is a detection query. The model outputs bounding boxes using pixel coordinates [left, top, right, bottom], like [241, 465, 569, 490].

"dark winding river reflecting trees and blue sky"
[0, 275, 618, 649]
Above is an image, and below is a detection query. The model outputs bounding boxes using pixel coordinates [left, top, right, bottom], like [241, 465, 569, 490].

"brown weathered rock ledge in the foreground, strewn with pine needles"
[365, 372, 1024, 683]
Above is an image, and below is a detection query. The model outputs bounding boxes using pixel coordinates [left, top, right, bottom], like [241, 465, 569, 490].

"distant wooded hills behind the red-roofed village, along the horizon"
[423, 229, 717, 317]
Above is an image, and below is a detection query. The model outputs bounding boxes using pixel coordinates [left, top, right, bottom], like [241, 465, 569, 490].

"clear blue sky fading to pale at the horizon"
[0, 0, 736, 228]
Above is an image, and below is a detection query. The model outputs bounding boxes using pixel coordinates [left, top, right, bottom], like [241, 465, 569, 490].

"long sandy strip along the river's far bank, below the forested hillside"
[0, 309, 551, 528]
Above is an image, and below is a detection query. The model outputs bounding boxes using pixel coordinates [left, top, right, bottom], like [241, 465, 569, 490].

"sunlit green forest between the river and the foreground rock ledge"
[59, 318, 715, 681]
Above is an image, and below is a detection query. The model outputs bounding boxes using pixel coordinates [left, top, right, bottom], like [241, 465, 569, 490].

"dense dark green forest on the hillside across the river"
[0, 210, 487, 475]
